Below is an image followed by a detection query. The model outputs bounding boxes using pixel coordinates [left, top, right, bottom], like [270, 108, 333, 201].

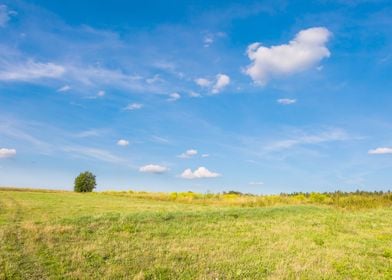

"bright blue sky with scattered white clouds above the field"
[0, 0, 392, 193]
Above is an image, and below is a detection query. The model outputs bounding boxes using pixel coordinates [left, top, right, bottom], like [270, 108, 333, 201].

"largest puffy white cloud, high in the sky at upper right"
[245, 27, 331, 85]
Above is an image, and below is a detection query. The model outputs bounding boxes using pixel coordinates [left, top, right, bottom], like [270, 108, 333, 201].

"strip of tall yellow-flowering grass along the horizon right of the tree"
[103, 191, 392, 209]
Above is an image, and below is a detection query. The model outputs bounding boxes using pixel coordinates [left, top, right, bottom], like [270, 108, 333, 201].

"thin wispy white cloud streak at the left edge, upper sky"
[0, 60, 65, 82]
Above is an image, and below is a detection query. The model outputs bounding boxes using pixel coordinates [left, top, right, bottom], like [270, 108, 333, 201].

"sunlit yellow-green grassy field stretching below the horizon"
[0, 189, 392, 279]
